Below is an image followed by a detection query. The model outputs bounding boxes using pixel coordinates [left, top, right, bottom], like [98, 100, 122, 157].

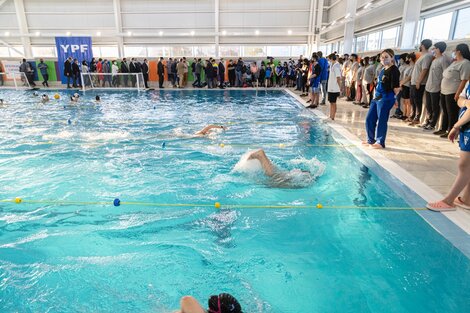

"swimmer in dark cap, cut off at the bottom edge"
[175, 293, 242, 313]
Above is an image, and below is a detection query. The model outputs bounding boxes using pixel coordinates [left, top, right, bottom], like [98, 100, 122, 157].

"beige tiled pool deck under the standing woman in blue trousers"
[288, 90, 470, 234]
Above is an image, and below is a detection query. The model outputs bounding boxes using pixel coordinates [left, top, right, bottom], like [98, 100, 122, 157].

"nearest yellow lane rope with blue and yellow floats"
[0, 199, 426, 211]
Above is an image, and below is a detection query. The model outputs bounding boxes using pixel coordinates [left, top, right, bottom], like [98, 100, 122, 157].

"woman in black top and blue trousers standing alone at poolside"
[363, 49, 400, 149]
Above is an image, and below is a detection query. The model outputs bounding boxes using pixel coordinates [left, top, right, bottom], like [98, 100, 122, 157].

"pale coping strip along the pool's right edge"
[284, 88, 470, 259]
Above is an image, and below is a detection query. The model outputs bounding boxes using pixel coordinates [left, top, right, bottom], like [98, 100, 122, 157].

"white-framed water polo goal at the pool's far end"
[81, 73, 145, 90]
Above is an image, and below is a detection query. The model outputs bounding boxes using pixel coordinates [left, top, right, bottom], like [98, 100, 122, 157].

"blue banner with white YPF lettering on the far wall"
[55, 37, 93, 84]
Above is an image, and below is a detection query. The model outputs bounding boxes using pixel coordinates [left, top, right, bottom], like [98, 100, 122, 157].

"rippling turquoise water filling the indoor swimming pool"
[0, 90, 470, 313]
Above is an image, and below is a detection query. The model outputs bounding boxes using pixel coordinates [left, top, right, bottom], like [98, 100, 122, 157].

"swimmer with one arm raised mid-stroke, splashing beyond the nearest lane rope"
[247, 149, 314, 188]
